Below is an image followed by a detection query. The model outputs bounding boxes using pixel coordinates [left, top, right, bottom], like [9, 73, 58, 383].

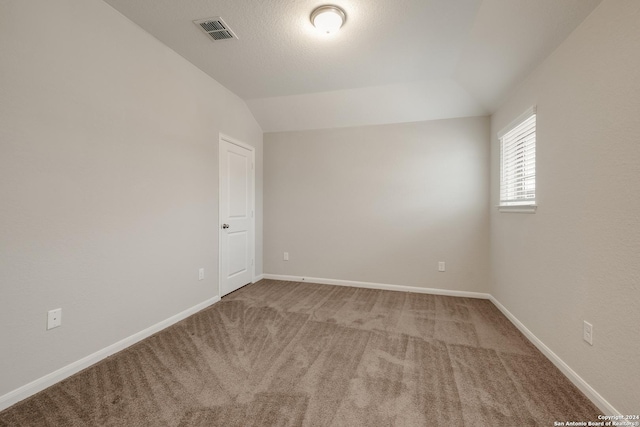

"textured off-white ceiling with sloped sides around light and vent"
[105, 0, 601, 132]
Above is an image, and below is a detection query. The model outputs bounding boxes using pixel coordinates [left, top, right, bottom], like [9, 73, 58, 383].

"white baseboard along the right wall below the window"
[489, 295, 621, 415]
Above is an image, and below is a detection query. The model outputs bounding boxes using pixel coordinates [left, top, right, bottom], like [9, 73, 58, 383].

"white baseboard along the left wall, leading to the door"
[0, 296, 220, 411]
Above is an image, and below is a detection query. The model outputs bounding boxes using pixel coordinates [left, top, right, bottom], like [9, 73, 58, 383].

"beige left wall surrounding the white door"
[0, 0, 262, 402]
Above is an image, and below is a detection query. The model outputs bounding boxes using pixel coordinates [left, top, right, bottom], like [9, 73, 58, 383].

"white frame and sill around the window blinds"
[498, 105, 538, 213]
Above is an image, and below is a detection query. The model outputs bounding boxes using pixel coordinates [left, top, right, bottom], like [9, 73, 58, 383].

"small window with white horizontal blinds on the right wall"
[498, 107, 536, 212]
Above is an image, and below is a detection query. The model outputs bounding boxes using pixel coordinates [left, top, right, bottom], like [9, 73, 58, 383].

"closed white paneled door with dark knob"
[219, 136, 255, 296]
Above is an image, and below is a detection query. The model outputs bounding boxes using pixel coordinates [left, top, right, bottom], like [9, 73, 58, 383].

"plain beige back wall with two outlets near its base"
[264, 117, 489, 292]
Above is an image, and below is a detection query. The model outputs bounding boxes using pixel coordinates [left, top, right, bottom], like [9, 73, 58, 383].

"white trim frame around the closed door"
[217, 132, 256, 298]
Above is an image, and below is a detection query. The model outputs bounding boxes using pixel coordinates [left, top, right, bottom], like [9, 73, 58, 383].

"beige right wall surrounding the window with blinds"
[491, 0, 640, 414]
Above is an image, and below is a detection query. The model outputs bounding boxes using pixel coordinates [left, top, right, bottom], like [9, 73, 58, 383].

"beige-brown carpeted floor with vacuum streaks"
[0, 280, 599, 427]
